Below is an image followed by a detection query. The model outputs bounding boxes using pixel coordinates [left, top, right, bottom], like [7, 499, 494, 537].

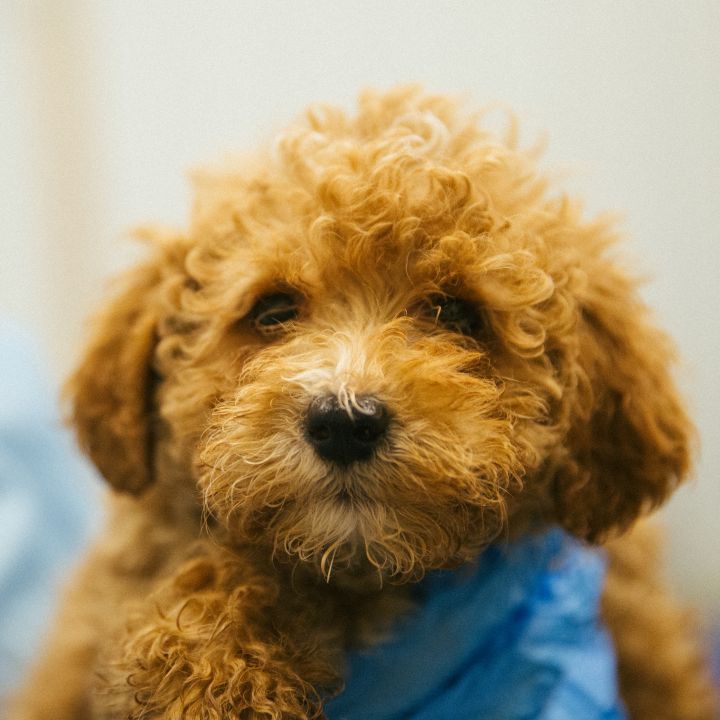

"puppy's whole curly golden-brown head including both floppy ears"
[72, 92, 688, 578]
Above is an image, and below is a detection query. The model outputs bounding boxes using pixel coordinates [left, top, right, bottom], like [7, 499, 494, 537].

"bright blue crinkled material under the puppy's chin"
[326, 529, 626, 720]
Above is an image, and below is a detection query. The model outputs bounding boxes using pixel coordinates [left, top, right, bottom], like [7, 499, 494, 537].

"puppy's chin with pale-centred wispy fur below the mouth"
[222, 483, 496, 592]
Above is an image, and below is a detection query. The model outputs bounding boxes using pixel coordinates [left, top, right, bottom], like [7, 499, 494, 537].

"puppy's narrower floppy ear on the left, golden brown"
[65, 255, 162, 493]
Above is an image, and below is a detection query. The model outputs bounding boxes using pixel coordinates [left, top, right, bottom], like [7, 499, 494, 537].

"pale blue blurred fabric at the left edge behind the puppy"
[0, 322, 99, 695]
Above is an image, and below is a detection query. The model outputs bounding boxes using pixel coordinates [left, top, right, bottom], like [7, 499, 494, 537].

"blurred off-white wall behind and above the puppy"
[0, 0, 720, 622]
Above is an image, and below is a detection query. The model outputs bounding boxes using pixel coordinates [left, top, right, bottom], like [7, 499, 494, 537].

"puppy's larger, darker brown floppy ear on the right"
[554, 264, 693, 540]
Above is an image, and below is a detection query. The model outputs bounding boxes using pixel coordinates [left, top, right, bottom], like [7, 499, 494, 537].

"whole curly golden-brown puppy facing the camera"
[9, 90, 713, 720]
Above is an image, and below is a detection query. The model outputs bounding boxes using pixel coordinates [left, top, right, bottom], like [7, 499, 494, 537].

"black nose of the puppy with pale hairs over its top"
[305, 395, 390, 465]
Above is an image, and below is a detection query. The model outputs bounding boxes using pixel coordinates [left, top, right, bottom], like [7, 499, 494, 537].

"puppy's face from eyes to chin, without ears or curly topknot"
[172, 219, 553, 573]
